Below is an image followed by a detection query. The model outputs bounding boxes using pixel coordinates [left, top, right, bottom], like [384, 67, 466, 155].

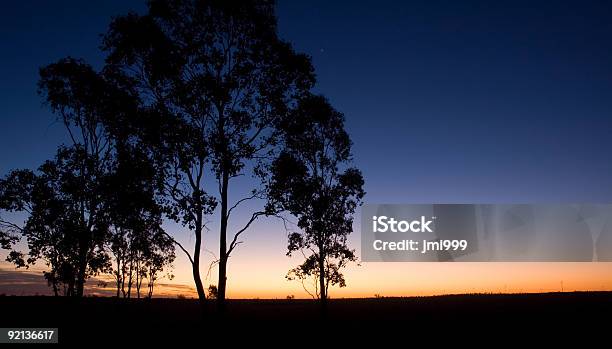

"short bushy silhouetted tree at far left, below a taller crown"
[0, 147, 109, 296]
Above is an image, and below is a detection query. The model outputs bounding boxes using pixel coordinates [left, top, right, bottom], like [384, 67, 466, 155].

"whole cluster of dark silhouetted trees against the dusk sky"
[0, 0, 364, 310]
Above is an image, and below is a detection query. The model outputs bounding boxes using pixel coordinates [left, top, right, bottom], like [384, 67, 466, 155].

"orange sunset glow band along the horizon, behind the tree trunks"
[0, 251, 612, 299]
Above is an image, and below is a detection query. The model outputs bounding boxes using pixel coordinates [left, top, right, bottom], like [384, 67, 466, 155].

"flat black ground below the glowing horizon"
[0, 292, 612, 347]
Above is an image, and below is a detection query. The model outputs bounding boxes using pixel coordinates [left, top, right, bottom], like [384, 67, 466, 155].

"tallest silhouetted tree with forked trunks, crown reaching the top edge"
[104, 0, 314, 308]
